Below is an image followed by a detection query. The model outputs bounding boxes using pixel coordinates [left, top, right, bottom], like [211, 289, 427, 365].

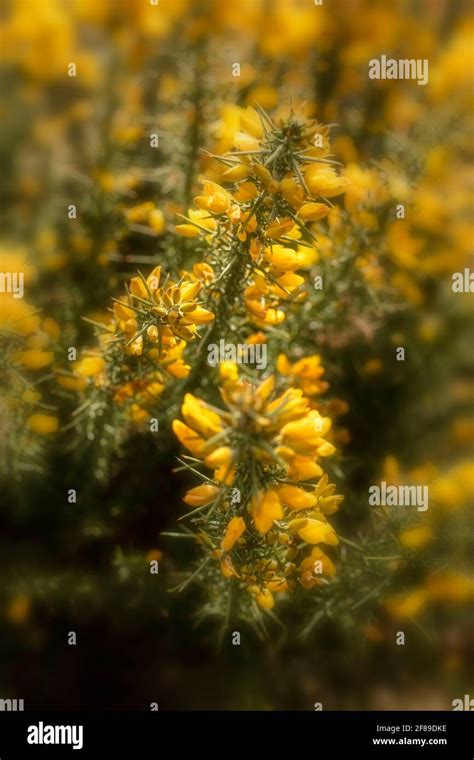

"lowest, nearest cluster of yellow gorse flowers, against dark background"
[173, 363, 342, 609]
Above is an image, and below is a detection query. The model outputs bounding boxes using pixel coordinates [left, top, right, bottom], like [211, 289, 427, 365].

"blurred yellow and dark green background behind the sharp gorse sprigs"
[0, 0, 474, 710]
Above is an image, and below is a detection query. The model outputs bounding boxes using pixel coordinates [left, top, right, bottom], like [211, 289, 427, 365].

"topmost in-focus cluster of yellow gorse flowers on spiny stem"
[176, 107, 349, 328]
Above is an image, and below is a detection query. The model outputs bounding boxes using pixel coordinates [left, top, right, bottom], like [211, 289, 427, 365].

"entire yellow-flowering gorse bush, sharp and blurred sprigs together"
[0, 0, 474, 706]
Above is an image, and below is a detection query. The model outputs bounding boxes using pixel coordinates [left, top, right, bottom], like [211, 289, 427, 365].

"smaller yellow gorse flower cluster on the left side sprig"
[58, 264, 214, 424]
